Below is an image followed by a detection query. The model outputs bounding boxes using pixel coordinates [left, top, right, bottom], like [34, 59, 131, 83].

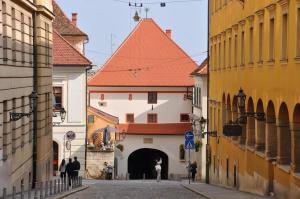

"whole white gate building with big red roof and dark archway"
[88, 19, 197, 179]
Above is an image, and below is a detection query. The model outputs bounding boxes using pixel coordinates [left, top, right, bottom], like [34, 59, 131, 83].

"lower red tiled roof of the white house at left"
[53, 30, 91, 66]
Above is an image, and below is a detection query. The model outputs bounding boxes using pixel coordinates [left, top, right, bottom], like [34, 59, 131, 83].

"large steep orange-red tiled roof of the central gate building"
[88, 19, 197, 86]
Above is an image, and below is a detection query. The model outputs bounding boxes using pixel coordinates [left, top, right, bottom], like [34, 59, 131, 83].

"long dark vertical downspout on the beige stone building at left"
[32, 8, 38, 188]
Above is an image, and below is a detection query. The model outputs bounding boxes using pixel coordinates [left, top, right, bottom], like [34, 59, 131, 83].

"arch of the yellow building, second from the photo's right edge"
[277, 103, 291, 165]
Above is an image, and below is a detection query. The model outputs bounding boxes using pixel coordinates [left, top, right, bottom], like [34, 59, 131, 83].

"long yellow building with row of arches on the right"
[208, 0, 300, 199]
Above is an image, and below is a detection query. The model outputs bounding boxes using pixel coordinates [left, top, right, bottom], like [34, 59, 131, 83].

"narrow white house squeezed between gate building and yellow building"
[192, 60, 207, 181]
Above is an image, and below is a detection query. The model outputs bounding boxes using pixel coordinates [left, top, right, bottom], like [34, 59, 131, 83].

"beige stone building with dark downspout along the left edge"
[0, 0, 54, 192]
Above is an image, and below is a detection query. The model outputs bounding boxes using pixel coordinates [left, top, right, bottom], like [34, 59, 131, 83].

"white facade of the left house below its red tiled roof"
[53, 66, 86, 174]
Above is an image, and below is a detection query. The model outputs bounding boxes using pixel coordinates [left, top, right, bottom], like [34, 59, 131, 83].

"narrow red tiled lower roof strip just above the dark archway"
[117, 123, 192, 135]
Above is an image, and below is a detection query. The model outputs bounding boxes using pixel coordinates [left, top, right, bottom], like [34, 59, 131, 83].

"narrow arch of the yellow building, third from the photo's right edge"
[266, 101, 277, 158]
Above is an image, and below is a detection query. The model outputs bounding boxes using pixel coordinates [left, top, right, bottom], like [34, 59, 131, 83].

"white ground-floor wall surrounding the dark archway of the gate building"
[117, 135, 188, 177]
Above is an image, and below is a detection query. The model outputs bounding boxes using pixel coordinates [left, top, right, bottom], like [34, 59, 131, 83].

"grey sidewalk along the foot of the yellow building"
[181, 181, 272, 199]
